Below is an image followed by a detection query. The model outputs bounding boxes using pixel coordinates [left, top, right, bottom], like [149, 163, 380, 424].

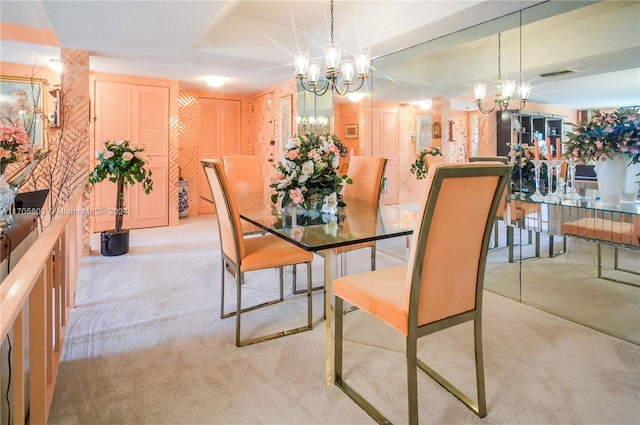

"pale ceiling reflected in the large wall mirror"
[373, 1, 640, 109]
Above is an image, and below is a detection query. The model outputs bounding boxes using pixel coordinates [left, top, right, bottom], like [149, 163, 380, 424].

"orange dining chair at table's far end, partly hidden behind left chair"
[222, 155, 267, 235]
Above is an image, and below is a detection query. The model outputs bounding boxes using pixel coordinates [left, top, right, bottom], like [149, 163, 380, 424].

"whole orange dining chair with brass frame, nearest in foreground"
[333, 162, 510, 424]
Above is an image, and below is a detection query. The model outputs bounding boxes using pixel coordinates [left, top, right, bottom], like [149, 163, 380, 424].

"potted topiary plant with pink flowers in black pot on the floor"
[89, 139, 153, 256]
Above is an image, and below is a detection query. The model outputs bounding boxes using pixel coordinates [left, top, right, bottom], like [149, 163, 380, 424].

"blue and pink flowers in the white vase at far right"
[565, 108, 640, 164]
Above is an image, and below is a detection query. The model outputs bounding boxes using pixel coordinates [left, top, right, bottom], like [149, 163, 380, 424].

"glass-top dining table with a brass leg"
[236, 194, 416, 385]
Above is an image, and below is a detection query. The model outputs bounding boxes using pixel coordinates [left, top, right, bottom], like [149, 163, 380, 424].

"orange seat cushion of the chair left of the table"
[240, 235, 313, 272]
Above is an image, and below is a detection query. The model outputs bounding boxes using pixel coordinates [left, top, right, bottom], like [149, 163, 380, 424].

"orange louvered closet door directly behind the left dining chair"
[198, 98, 242, 214]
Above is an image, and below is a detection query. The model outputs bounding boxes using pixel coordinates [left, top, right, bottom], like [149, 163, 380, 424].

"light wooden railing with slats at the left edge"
[0, 189, 83, 424]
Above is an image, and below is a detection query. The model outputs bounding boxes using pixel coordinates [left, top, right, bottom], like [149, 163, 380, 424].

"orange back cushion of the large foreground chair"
[406, 162, 503, 326]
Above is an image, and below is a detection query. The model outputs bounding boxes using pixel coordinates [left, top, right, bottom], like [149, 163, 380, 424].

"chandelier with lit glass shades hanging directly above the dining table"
[293, 0, 371, 96]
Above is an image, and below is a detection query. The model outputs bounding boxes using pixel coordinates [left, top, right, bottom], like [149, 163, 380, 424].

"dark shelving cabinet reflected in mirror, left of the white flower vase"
[496, 110, 565, 156]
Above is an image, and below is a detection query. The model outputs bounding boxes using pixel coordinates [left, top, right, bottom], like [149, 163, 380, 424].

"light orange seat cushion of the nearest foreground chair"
[333, 265, 409, 336]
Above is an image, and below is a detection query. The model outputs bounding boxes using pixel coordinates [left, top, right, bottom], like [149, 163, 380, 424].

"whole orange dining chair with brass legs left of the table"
[202, 160, 313, 347]
